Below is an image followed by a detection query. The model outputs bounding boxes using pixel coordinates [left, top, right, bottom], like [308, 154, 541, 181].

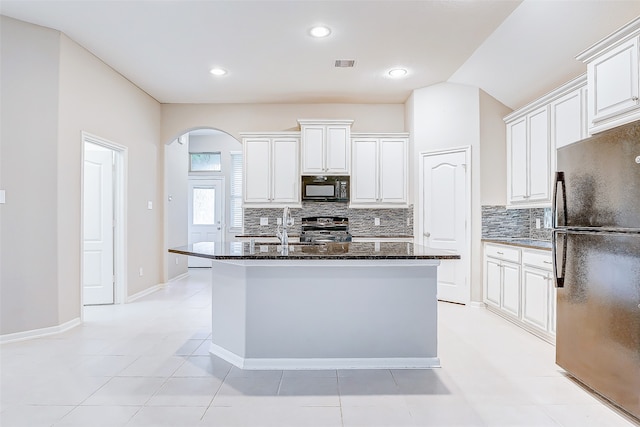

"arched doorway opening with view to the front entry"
[165, 127, 242, 279]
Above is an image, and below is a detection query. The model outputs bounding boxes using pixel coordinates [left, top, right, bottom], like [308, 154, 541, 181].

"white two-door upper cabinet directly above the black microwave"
[298, 120, 353, 175]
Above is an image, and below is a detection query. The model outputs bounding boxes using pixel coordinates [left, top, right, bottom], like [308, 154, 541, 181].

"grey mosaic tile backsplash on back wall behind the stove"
[244, 202, 413, 237]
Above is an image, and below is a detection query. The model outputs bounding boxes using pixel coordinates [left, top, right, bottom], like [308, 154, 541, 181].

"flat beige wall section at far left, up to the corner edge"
[0, 17, 60, 334]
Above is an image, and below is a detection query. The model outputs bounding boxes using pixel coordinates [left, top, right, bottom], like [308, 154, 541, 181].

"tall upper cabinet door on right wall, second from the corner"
[528, 106, 551, 202]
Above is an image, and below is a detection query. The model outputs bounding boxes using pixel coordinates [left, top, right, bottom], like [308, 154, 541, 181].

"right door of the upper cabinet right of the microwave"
[380, 139, 407, 203]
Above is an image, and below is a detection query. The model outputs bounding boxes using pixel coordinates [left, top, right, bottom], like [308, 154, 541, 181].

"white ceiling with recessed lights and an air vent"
[0, 0, 640, 108]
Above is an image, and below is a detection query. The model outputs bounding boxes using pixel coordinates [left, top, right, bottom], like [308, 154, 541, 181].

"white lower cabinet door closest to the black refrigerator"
[522, 267, 549, 331]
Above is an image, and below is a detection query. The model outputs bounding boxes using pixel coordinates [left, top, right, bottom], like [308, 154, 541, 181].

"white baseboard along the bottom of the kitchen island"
[209, 343, 441, 371]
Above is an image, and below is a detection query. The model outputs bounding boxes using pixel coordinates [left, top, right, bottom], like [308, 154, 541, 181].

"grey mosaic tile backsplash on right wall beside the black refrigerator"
[482, 206, 551, 241]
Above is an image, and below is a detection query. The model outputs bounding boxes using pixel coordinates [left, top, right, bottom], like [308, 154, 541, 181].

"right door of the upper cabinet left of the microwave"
[271, 138, 300, 203]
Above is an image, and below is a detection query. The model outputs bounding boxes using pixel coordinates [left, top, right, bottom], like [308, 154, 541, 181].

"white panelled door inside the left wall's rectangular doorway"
[82, 142, 115, 305]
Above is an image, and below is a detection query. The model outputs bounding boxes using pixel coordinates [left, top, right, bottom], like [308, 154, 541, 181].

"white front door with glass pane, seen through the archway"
[187, 178, 224, 267]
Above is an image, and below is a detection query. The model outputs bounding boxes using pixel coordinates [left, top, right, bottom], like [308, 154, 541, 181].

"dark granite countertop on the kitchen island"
[169, 242, 460, 260]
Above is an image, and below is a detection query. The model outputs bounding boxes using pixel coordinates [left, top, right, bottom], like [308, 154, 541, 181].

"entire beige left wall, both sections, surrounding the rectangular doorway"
[0, 17, 164, 335]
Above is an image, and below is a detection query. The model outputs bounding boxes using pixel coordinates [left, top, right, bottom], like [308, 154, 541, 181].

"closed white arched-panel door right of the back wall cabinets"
[419, 149, 470, 304]
